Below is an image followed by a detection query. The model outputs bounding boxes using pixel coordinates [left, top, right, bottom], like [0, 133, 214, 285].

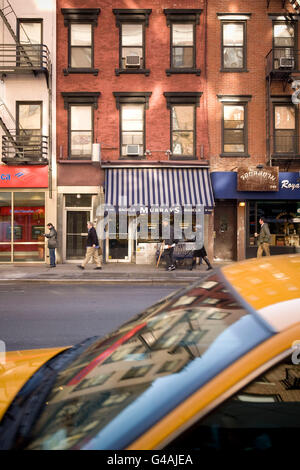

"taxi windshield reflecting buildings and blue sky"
[24, 275, 271, 450]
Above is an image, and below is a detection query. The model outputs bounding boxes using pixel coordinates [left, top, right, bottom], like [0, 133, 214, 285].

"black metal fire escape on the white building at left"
[0, 0, 51, 165]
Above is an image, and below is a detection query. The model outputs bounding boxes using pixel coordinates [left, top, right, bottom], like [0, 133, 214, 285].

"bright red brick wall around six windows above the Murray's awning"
[57, 0, 209, 169]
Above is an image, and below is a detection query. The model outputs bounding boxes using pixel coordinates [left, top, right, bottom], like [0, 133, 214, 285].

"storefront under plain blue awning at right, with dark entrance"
[211, 168, 300, 259]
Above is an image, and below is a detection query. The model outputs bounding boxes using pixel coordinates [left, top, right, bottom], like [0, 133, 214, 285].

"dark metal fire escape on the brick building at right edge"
[265, 0, 300, 171]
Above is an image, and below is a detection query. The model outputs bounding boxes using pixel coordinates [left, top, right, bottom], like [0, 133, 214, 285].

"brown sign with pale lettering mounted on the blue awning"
[237, 166, 279, 191]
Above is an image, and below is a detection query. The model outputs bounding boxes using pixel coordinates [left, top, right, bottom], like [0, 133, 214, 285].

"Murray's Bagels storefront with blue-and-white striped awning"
[104, 167, 214, 264]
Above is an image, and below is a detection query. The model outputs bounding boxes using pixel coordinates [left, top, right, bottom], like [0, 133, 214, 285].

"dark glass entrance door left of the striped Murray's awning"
[66, 210, 91, 260]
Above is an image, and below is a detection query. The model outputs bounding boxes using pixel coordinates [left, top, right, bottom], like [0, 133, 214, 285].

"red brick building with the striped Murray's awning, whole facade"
[57, 0, 213, 262]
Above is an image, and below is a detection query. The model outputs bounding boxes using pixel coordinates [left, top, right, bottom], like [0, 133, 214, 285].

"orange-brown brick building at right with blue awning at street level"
[207, 0, 300, 260]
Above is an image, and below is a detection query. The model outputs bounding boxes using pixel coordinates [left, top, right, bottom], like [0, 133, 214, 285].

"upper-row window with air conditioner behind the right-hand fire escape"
[273, 21, 296, 69]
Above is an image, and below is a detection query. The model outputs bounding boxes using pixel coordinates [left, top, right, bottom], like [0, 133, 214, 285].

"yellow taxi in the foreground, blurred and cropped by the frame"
[0, 254, 300, 454]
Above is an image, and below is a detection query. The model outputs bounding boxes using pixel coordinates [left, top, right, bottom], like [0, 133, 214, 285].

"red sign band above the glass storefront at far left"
[0, 165, 48, 188]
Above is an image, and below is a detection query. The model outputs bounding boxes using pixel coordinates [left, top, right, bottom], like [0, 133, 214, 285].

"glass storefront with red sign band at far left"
[0, 165, 48, 263]
